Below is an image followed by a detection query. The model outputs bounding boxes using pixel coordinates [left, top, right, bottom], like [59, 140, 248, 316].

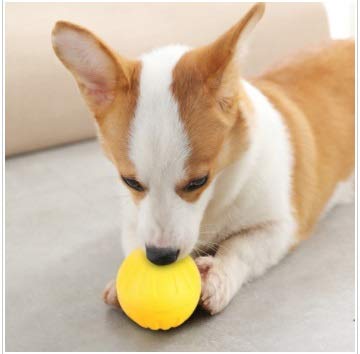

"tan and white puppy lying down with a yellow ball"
[52, 3, 355, 314]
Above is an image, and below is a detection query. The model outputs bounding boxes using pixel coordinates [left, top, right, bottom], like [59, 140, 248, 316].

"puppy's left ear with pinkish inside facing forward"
[52, 21, 136, 116]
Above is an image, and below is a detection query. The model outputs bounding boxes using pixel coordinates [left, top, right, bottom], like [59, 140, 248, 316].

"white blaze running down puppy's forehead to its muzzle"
[129, 46, 212, 256]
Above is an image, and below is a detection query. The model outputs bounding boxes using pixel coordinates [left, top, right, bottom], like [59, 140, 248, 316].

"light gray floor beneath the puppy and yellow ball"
[6, 141, 355, 351]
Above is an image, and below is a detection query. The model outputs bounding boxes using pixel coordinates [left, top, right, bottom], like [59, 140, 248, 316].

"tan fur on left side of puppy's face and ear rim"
[53, 21, 144, 202]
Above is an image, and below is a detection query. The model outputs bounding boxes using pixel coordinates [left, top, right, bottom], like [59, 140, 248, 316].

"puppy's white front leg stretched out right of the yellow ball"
[195, 222, 295, 314]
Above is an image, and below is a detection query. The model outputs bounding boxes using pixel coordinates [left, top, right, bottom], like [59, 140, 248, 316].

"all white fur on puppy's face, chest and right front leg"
[119, 54, 296, 313]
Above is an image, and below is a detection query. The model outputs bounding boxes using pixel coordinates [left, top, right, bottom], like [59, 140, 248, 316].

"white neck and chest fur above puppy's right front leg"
[201, 82, 293, 242]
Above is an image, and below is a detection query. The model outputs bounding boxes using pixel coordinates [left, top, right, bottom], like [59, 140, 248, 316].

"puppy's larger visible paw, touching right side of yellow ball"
[195, 256, 231, 315]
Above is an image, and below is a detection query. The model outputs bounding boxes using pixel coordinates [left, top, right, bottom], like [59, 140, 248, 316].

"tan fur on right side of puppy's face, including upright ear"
[172, 3, 264, 202]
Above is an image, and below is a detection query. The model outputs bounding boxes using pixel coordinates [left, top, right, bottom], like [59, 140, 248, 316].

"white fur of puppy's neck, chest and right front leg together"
[197, 82, 296, 314]
